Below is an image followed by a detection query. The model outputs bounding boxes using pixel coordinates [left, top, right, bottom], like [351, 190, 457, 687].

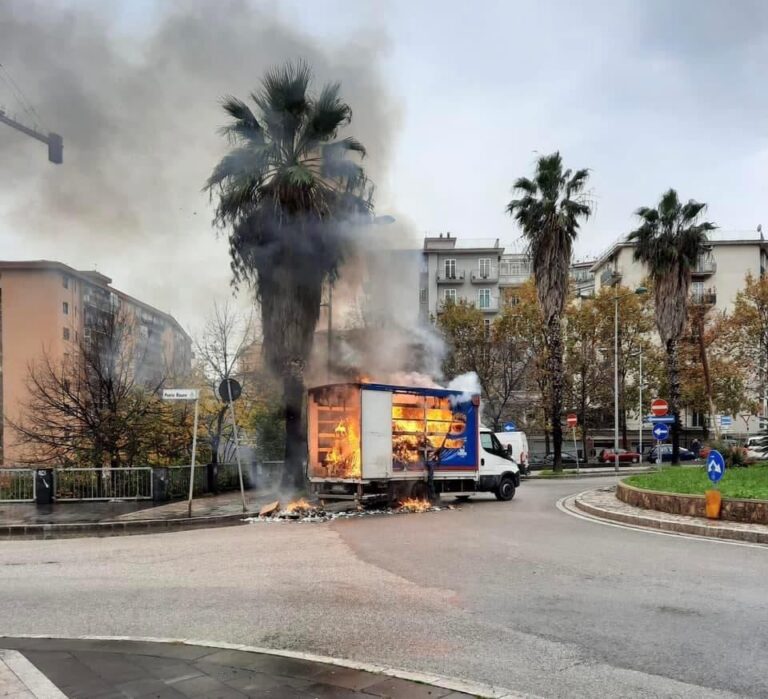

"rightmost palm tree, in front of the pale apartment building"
[628, 189, 716, 464]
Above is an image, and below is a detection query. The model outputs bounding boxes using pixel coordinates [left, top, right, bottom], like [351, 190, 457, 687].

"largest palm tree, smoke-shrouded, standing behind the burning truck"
[206, 62, 372, 488]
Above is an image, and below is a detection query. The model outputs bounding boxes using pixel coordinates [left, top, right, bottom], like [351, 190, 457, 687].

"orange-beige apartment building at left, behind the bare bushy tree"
[0, 260, 192, 463]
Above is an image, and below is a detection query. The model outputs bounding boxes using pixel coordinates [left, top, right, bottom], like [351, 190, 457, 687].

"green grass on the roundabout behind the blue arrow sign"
[624, 464, 768, 500]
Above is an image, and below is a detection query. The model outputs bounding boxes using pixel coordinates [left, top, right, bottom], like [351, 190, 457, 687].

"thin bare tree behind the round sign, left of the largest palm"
[195, 301, 255, 464]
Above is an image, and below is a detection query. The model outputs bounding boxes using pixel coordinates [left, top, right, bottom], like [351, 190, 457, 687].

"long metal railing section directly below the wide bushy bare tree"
[53, 466, 153, 501]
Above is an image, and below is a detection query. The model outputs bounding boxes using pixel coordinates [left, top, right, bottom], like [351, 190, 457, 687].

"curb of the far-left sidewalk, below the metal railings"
[0, 512, 258, 541]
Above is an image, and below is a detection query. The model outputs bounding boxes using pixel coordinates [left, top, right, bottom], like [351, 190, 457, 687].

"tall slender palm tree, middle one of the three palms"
[507, 152, 592, 471]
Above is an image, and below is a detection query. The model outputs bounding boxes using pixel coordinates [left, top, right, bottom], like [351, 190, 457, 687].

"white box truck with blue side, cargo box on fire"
[307, 382, 520, 502]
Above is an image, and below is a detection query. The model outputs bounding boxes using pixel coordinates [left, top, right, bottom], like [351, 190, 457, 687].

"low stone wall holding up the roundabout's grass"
[616, 481, 768, 524]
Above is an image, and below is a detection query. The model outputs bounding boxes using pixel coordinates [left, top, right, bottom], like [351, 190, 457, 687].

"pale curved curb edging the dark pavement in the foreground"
[0, 633, 538, 699]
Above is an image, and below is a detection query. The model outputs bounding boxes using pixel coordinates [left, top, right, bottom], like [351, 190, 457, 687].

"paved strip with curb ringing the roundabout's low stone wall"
[565, 486, 768, 544]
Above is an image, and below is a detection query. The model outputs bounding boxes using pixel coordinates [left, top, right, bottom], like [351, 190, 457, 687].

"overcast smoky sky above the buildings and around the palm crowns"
[0, 0, 768, 326]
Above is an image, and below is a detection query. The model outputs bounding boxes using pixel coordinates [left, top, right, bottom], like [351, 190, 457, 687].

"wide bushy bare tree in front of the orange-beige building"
[8, 310, 163, 468]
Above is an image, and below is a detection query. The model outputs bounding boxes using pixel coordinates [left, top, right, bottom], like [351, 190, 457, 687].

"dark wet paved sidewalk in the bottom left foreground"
[0, 638, 484, 699]
